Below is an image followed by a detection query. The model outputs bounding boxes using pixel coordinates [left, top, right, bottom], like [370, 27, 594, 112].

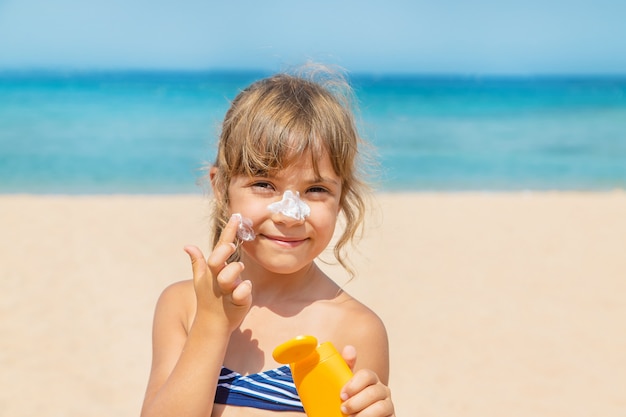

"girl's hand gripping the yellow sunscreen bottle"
[341, 346, 395, 417]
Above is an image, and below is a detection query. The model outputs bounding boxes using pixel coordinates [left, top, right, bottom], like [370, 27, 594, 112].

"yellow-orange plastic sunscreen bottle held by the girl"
[272, 336, 352, 417]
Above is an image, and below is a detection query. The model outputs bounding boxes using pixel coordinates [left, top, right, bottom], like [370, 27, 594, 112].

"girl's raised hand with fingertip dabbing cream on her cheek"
[185, 217, 252, 332]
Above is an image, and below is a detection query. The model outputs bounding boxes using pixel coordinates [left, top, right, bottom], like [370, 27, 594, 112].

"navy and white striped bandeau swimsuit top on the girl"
[215, 365, 304, 413]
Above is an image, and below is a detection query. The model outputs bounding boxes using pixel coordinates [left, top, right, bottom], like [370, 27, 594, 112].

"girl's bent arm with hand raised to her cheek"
[141, 214, 251, 417]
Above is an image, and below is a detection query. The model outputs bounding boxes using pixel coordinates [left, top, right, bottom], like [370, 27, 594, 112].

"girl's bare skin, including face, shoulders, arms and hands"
[142, 154, 394, 417]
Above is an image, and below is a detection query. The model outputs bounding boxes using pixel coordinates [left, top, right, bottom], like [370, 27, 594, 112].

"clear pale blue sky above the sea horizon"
[0, 0, 626, 75]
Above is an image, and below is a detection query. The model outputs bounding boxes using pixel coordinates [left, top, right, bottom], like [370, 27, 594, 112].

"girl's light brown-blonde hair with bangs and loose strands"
[207, 67, 369, 276]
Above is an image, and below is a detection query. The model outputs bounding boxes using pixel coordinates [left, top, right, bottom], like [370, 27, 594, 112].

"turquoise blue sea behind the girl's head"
[0, 71, 626, 194]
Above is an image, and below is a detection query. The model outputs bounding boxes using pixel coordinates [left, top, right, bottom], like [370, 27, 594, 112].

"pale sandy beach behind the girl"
[0, 191, 626, 417]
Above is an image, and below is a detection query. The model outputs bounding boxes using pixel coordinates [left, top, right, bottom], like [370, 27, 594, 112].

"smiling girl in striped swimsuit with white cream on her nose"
[142, 66, 394, 417]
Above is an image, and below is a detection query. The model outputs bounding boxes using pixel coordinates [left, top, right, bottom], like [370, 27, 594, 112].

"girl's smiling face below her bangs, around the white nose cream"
[228, 153, 341, 274]
